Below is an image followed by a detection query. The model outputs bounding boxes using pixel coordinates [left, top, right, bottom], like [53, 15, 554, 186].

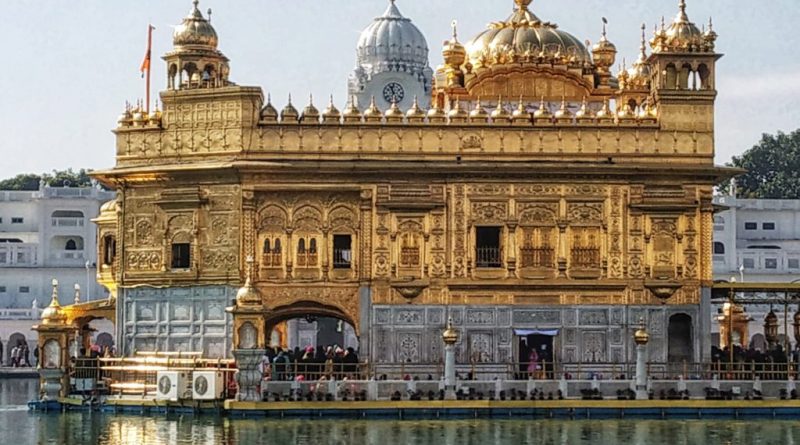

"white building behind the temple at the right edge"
[712, 196, 800, 350]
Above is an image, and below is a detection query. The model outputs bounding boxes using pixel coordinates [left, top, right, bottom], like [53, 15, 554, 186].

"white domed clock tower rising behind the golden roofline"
[347, 0, 433, 110]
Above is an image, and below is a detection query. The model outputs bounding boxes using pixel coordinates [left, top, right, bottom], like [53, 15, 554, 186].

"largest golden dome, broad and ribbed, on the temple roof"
[466, 0, 592, 70]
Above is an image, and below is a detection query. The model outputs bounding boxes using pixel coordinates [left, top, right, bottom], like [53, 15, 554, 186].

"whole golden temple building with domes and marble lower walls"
[90, 0, 731, 363]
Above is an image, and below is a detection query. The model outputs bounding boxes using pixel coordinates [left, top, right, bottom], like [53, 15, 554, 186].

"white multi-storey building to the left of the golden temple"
[0, 185, 116, 363]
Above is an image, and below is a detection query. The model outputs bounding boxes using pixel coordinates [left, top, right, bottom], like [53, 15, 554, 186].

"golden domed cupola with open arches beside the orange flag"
[164, 0, 231, 90]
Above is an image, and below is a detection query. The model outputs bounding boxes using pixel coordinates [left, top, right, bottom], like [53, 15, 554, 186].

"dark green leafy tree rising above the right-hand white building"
[720, 130, 800, 199]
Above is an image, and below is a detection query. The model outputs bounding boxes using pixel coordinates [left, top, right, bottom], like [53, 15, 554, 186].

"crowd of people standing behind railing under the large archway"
[261, 345, 360, 381]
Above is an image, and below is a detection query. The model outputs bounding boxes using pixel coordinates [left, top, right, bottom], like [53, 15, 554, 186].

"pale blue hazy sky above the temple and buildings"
[0, 0, 800, 178]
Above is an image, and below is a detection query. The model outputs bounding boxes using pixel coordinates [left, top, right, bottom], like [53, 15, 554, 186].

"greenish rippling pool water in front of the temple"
[0, 380, 800, 445]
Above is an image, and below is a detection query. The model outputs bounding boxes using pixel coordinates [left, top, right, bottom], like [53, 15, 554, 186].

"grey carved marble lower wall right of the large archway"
[370, 306, 700, 363]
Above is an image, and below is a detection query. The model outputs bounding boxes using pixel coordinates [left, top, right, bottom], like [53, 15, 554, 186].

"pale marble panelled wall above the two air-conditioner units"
[117, 286, 236, 358]
